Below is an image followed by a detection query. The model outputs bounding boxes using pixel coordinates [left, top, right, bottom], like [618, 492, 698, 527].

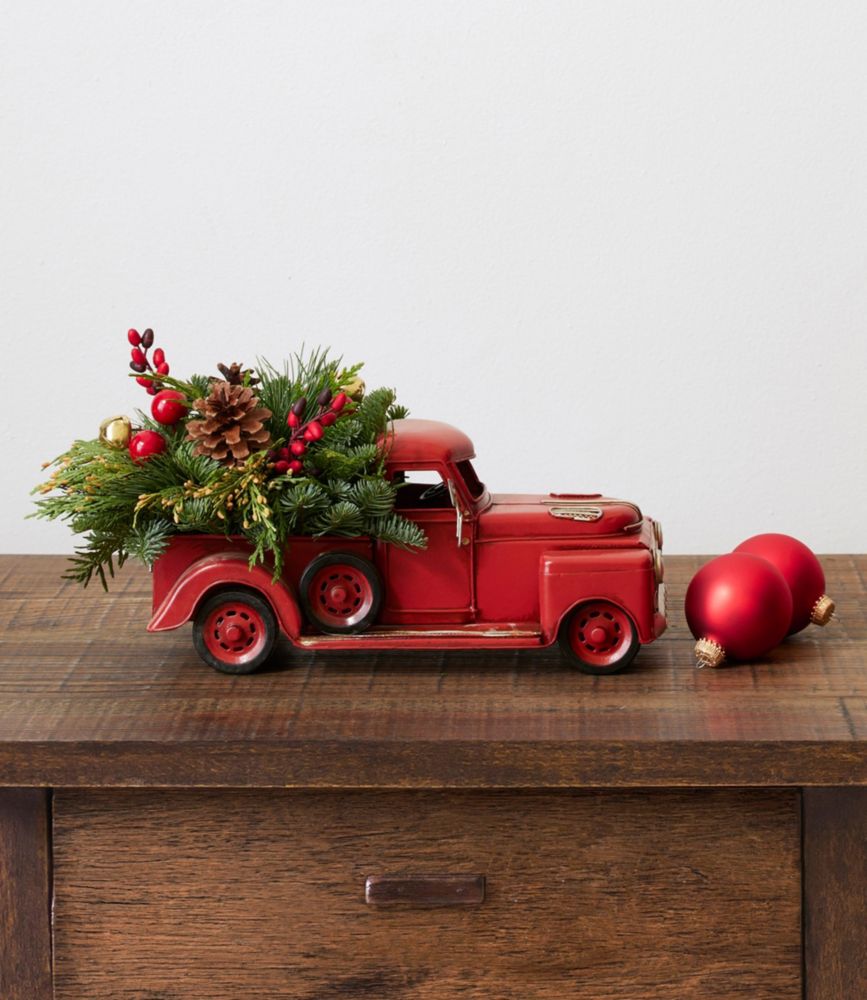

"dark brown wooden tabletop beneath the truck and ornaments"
[0, 556, 867, 788]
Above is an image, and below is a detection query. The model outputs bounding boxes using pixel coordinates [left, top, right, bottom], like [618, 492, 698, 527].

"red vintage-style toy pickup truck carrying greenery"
[148, 419, 665, 674]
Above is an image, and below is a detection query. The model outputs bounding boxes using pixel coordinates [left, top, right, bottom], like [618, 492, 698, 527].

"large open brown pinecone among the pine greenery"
[187, 382, 271, 465]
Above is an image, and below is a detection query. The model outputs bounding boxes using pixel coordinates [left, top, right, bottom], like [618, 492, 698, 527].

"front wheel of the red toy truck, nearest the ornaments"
[559, 601, 638, 674]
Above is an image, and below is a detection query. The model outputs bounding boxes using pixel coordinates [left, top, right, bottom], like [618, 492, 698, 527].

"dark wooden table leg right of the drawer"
[804, 788, 867, 1000]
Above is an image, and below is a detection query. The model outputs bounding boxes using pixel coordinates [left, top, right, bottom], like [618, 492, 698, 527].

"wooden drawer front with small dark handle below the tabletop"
[54, 790, 801, 1000]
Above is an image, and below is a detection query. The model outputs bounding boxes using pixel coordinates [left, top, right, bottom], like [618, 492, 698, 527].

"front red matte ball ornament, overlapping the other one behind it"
[685, 552, 792, 667]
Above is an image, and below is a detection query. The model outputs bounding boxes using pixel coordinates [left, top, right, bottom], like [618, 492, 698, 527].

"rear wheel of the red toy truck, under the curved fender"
[193, 590, 277, 674]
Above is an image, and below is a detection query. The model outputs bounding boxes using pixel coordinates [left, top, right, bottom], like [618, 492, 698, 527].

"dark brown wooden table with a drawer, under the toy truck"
[0, 556, 867, 1000]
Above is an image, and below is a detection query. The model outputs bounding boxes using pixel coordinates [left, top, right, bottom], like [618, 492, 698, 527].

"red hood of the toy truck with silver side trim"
[478, 493, 642, 540]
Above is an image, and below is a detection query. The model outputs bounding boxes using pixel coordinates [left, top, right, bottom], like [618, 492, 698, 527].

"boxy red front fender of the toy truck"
[539, 548, 655, 643]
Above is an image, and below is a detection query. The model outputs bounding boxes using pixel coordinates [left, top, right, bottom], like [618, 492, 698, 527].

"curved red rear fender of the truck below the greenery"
[147, 552, 301, 638]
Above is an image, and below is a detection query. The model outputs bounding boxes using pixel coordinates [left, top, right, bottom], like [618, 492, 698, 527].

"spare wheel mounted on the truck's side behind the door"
[298, 552, 382, 635]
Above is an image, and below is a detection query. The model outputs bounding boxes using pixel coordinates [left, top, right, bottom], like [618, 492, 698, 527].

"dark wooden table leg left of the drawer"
[0, 788, 53, 1000]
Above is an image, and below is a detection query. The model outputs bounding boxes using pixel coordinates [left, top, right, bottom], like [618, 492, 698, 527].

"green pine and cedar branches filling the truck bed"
[32, 350, 426, 589]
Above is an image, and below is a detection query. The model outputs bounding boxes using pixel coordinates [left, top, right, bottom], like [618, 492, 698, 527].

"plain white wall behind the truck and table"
[0, 0, 867, 552]
